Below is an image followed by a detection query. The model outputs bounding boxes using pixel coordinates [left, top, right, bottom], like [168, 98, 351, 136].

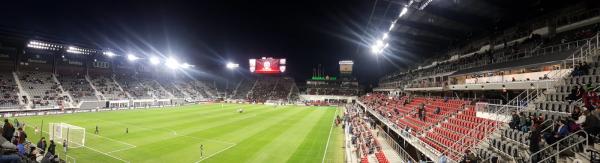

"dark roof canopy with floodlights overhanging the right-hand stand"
[368, 0, 597, 63]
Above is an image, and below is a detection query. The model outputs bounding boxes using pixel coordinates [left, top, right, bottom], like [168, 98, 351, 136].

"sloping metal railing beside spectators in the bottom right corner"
[528, 130, 589, 163]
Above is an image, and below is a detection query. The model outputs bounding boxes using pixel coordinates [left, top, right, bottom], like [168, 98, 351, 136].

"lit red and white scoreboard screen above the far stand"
[249, 57, 286, 74]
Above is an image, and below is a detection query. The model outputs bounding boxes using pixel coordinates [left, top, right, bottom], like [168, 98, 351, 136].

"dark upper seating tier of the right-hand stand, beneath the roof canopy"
[380, 23, 600, 90]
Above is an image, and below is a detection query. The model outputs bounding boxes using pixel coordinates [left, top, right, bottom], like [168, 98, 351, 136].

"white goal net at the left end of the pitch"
[48, 123, 85, 148]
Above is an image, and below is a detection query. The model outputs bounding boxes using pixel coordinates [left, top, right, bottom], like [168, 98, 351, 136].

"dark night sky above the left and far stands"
[0, 0, 404, 85]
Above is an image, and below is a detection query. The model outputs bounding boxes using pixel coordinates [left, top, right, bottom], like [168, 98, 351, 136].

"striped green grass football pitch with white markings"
[11, 104, 345, 163]
